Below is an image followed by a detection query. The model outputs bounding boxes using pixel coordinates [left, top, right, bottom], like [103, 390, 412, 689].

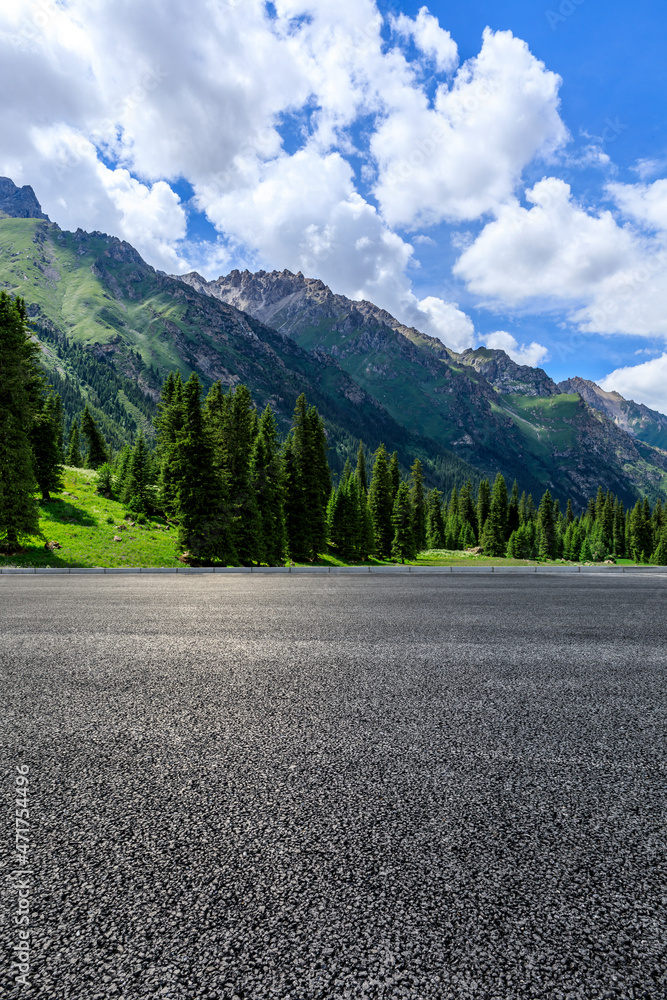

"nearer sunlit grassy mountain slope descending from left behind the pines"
[0, 217, 480, 488]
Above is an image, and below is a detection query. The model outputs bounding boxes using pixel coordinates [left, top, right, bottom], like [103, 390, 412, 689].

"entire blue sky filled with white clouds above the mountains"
[0, 0, 667, 412]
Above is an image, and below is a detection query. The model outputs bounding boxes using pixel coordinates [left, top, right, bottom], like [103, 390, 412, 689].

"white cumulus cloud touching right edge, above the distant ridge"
[453, 177, 667, 336]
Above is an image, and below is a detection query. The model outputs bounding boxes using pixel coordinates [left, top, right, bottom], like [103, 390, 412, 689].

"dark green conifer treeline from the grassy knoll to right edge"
[104, 373, 667, 565]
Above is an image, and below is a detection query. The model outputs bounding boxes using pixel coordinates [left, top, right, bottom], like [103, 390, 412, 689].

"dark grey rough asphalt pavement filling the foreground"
[0, 575, 667, 1000]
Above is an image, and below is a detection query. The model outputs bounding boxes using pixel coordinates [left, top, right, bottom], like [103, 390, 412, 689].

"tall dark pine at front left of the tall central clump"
[173, 373, 236, 564]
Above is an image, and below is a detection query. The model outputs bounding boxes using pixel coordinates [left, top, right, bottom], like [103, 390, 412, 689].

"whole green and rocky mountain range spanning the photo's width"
[0, 178, 667, 506]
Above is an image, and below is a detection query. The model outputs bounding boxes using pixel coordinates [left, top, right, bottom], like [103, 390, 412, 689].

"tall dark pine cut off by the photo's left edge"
[0, 292, 43, 551]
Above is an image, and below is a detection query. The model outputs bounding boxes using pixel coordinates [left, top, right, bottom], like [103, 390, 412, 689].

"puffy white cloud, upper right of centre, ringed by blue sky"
[371, 28, 568, 226]
